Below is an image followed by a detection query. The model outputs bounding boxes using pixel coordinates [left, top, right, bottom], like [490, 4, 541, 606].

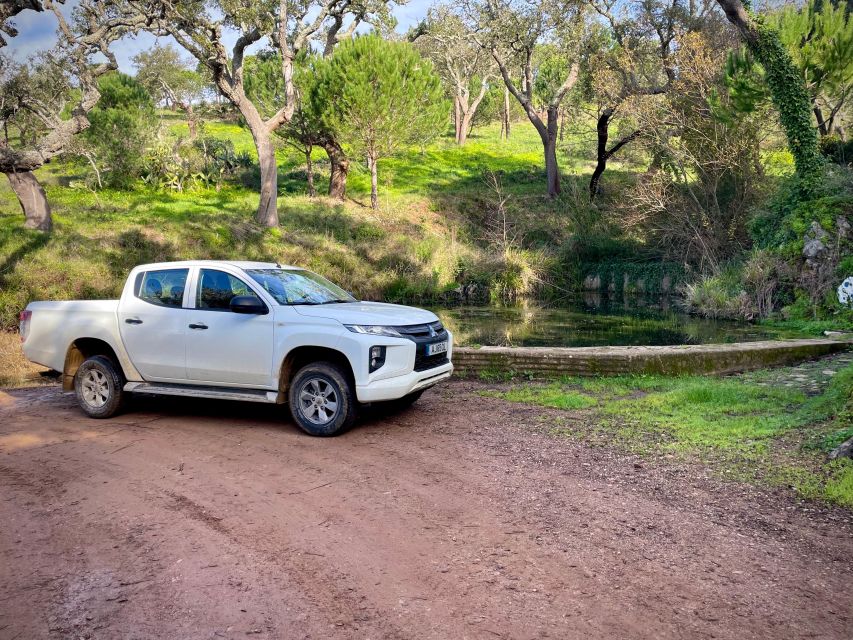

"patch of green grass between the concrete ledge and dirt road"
[482, 365, 853, 507]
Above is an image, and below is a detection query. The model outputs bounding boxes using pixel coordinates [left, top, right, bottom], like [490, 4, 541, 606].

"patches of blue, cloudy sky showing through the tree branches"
[0, 0, 434, 74]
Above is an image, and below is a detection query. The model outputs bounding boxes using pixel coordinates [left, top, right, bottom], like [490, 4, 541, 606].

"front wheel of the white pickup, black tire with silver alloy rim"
[287, 362, 358, 437]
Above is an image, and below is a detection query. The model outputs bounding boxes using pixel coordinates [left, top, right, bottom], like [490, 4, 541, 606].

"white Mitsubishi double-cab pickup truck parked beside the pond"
[20, 260, 453, 436]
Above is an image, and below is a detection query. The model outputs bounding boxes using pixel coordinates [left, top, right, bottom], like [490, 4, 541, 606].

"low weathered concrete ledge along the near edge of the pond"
[453, 336, 853, 378]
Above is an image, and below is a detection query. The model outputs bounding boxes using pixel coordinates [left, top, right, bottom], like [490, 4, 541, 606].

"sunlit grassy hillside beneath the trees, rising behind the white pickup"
[0, 114, 652, 328]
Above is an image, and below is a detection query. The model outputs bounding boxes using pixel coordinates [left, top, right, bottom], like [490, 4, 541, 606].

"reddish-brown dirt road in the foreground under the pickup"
[0, 382, 853, 640]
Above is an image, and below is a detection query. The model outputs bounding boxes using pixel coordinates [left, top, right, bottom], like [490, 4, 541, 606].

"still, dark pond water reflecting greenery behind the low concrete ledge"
[432, 293, 802, 347]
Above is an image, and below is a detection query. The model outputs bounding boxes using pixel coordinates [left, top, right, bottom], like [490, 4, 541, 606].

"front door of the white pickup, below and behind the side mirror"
[186, 269, 275, 387]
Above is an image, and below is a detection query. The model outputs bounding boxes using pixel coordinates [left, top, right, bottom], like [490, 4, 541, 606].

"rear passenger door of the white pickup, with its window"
[118, 268, 189, 381]
